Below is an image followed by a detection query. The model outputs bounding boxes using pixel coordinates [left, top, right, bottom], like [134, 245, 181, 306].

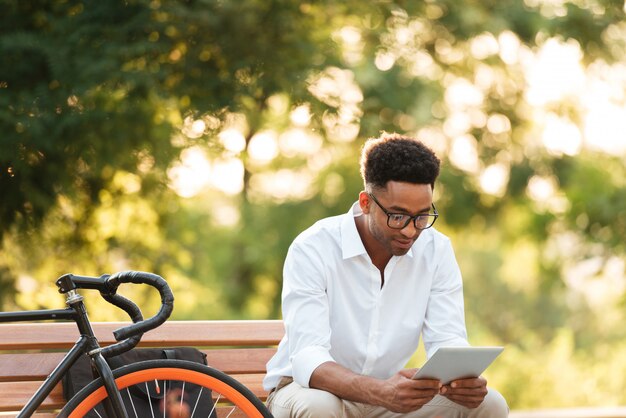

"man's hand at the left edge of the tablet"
[381, 369, 441, 413]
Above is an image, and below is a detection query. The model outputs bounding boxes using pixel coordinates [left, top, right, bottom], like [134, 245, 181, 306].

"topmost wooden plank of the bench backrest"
[0, 320, 284, 350]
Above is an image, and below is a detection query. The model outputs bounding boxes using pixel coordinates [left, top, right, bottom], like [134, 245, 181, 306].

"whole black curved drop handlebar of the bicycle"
[57, 271, 174, 357]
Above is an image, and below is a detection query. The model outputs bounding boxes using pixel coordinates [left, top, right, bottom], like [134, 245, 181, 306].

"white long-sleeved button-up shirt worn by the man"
[263, 204, 468, 390]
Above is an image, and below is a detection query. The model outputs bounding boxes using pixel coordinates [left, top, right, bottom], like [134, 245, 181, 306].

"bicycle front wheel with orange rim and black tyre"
[59, 360, 272, 418]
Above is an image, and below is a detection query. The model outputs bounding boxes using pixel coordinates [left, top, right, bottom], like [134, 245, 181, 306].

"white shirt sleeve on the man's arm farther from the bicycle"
[422, 239, 469, 358]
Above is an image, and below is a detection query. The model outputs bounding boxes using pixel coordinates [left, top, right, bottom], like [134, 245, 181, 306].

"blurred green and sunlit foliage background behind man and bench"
[0, 0, 626, 409]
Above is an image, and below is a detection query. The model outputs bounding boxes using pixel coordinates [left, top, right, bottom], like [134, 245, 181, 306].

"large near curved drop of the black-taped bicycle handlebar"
[106, 271, 174, 341]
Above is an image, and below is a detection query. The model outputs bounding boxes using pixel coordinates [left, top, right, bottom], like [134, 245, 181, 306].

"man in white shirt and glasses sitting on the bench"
[264, 134, 508, 418]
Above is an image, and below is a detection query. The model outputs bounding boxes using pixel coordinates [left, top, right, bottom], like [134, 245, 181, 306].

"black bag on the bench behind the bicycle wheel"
[62, 347, 217, 418]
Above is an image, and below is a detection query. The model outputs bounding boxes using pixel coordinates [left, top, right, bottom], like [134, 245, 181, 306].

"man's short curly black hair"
[361, 133, 440, 189]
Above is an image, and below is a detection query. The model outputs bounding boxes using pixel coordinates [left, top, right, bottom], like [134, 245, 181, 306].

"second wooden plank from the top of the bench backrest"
[0, 348, 276, 382]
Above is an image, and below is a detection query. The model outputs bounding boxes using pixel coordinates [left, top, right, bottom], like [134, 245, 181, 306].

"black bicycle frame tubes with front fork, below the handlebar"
[0, 290, 127, 418]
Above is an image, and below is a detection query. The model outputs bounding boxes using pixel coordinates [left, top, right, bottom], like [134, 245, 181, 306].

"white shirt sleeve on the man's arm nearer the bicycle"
[282, 237, 335, 387]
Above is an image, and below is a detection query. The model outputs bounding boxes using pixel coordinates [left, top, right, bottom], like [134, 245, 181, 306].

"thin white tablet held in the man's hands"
[413, 347, 504, 385]
